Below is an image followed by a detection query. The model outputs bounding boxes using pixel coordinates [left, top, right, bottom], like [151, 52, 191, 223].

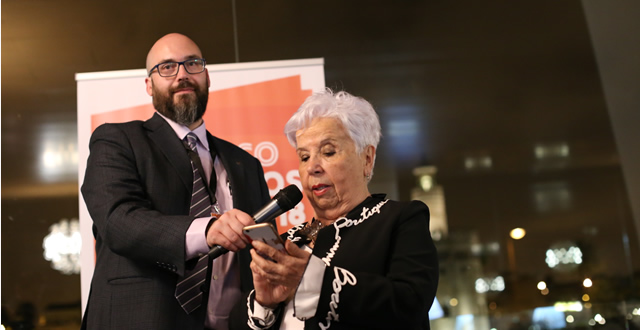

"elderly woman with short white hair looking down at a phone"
[232, 89, 438, 329]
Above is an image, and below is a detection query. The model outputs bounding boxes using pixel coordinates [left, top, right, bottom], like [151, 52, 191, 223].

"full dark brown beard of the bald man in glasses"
[152, 81, 209, 127]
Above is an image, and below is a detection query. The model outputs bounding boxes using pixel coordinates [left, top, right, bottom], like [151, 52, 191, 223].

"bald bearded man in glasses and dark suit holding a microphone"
[82, 33, 269, 330]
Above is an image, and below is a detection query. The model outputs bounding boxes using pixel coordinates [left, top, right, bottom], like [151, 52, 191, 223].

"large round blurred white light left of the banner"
[42, 218, 82, 275]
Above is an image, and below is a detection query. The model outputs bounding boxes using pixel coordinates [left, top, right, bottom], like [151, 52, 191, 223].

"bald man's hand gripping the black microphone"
[207, 209, 255, 252]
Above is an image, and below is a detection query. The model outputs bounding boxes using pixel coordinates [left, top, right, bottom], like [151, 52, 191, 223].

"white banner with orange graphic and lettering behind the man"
[76, 58, 325, 313]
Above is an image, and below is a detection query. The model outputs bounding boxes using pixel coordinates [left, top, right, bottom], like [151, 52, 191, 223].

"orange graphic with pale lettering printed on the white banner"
[91, 76, 313, 233]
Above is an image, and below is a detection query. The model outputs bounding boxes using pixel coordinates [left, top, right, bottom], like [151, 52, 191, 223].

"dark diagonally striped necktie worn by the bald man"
[175, 133, 211, 314]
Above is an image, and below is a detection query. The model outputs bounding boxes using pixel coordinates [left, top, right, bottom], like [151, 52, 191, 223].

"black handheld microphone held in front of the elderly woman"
[207, 185, 302, 259]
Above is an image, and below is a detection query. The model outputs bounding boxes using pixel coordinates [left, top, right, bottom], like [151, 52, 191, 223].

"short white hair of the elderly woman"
[284, 88, 381, 174]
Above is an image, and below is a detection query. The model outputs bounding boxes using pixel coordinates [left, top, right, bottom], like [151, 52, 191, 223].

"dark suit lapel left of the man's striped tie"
[144, 113, 193, 191]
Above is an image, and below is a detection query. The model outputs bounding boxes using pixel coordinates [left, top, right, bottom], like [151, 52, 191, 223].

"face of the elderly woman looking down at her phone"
[296, 118, 375, 220]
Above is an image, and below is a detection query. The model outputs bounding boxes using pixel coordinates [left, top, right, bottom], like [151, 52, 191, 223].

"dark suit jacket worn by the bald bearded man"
[82, 114, 269, 330]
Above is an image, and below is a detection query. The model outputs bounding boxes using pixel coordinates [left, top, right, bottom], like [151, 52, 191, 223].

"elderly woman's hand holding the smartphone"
[251, 240, 311, 308]
